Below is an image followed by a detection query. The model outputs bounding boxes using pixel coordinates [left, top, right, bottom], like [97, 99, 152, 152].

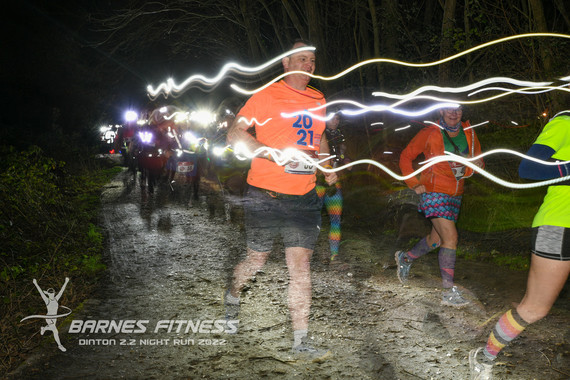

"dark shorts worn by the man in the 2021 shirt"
[244, 185, 322, 252]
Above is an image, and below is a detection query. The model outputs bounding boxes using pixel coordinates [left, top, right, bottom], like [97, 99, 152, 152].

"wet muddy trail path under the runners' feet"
[8, 172, 570, 379]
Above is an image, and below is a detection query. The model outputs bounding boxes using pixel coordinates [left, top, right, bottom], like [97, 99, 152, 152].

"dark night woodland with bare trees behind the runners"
[0, 0, 570, 150]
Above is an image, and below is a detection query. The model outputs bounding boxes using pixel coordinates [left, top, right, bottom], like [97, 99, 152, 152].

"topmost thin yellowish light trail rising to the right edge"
[230, 33, 570, 95]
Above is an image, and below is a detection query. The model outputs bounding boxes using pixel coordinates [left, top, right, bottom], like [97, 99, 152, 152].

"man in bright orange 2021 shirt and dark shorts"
[224, 41, 337, 358]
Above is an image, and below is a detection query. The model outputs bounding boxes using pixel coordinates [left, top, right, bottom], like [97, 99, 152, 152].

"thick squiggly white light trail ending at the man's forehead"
[147, 46, 315, 100]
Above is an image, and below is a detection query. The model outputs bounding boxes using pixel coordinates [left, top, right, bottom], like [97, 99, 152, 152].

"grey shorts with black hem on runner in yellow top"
[532, 226, 570, 261]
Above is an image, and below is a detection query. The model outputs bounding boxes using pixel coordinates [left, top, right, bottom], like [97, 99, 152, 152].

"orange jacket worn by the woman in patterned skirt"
[400, 121, 481, 196]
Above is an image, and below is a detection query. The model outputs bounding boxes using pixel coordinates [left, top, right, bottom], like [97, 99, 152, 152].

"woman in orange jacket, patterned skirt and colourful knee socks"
[395, 107, 483, 307]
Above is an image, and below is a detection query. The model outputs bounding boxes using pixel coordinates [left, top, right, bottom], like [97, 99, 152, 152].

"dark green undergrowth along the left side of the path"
[0, 146, 120, 374]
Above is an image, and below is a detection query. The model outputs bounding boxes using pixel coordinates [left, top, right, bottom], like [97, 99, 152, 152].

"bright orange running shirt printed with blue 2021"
[237, 81, 326, 195]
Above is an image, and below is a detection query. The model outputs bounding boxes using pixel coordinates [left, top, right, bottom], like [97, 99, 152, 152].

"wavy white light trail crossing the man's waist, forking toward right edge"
[234, 143, 570, 189]
